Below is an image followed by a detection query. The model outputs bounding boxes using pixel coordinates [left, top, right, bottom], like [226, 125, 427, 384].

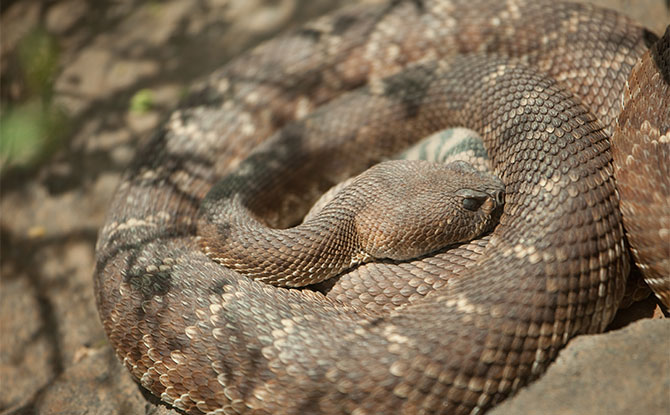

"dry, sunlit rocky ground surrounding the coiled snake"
[0, 0, 670, 414]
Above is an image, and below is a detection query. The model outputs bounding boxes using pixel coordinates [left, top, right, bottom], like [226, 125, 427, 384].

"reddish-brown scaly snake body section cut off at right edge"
[612, 27, 670, 308]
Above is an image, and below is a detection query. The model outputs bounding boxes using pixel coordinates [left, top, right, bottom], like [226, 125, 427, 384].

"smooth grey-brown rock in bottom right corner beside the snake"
[490, 319, 670, 415]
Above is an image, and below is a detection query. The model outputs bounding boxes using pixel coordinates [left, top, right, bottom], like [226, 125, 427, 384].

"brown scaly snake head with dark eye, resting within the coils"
[356, 160, 505, 260]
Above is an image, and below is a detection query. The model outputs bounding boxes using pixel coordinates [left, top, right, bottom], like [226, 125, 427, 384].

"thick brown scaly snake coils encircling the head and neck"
[95, 0, 667, 415]
